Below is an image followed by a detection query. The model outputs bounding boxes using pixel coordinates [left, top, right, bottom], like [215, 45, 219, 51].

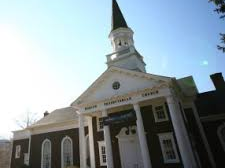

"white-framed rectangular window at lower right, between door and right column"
[158, 132, 179, 163]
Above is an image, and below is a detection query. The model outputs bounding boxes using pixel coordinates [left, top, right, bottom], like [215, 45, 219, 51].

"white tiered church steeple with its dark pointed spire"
[107, 0, 146, 72]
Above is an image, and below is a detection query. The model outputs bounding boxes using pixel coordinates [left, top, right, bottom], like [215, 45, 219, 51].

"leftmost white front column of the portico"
[79, 114, 87, 168]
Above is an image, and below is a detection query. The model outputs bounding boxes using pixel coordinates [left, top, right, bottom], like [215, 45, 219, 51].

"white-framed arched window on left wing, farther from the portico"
[41, 139, 51, 168]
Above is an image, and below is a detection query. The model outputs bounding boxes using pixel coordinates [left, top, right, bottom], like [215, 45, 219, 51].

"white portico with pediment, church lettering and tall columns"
[72, 67, 195, 168]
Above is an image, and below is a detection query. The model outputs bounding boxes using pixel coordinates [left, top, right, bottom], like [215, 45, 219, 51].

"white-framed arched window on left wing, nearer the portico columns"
[61, 136, 73, 168]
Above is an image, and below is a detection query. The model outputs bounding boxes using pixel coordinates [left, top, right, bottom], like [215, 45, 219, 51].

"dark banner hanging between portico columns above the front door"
[103, 111, 137, 125]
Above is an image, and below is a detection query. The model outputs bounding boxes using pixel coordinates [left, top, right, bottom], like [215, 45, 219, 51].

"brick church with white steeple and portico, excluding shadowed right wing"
[11, 0, 220, 168]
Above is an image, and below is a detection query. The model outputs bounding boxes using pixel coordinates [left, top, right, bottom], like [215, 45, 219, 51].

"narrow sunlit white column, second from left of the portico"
[87, 117, 95, 168]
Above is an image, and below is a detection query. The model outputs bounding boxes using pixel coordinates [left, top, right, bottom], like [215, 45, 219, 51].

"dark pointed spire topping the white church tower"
[112, 0, 128, 31]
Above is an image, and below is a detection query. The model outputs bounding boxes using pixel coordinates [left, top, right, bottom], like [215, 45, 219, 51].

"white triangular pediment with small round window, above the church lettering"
[72, 67, 172, 106]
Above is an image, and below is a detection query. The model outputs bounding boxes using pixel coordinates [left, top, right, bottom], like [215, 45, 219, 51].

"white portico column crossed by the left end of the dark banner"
[102, 110, 114, 168]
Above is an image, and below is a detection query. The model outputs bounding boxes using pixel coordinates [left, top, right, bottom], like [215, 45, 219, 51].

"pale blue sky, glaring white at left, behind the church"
[0, 0, 225, 138]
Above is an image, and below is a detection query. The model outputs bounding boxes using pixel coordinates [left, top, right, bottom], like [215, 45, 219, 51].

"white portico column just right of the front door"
[133, 103, 152, 168]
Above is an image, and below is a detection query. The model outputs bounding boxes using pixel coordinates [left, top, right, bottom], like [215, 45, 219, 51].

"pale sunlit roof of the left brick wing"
[29, 107, 78, 128]
